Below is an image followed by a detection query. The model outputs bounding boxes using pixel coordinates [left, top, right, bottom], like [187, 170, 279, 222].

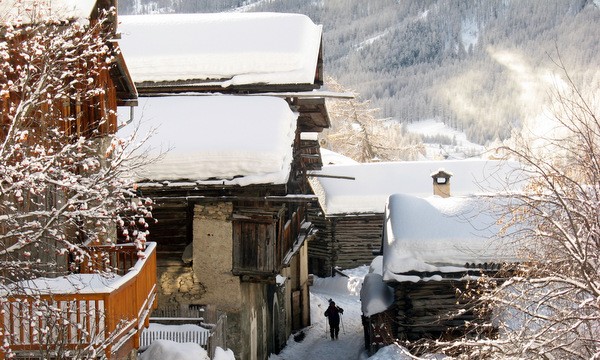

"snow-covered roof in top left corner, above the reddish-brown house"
[0, 0, 96, 24]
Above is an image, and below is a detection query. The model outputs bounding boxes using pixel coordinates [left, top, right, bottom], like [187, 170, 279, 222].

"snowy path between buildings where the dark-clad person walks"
[269, 266, 368, 360]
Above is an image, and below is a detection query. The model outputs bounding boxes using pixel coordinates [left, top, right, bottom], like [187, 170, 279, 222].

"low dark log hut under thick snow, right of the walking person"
[361, 191, 516, 353]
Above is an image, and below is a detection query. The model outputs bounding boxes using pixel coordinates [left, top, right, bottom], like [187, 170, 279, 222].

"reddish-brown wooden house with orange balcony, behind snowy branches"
[0, 0, 156, 359]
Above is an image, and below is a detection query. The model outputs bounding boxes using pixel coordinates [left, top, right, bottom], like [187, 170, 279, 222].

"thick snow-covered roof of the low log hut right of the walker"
[382, 194, 517, 281]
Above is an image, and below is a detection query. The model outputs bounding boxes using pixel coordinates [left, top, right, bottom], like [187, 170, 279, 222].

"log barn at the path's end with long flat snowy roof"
[308, 159, 514, 276]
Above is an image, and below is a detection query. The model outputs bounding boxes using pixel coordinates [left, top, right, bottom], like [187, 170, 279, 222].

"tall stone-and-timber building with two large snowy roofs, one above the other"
[116, 13, 329, 359]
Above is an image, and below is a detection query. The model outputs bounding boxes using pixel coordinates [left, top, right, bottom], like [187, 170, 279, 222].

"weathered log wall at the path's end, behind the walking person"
[308, 210, 383, 276]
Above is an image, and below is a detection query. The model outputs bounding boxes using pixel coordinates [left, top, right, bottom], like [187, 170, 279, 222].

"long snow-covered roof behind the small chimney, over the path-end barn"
[310, 159, 522, 216]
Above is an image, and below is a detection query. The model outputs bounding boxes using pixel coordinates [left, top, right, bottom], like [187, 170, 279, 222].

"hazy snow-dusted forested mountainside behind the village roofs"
[119, 0, 600, 144]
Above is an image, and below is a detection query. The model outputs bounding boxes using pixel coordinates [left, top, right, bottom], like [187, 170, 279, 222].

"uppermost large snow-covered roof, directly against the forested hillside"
[119, 13, 322, 87]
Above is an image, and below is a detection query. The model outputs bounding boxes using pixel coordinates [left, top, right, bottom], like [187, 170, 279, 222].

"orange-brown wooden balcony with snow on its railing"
[0, 243, 157, 359]
